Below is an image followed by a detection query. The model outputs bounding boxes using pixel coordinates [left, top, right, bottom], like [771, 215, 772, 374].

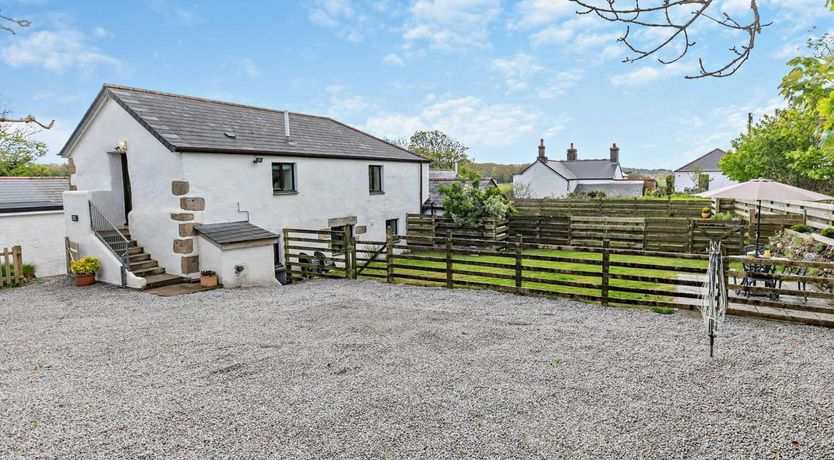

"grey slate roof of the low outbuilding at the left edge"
[0, 177, 69, 212]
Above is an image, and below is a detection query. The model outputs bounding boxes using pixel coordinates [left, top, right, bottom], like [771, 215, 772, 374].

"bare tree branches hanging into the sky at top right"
[570, 0, 770, 79]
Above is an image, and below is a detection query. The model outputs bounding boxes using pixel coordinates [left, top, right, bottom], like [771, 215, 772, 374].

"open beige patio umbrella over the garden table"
[695, 179, 834, 255]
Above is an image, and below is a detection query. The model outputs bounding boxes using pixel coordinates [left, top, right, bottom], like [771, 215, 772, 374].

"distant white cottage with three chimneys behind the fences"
[513, 139, 645, 198]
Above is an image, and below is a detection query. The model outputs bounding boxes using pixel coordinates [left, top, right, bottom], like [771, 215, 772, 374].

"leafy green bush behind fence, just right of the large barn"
[440, 170, 516, 225]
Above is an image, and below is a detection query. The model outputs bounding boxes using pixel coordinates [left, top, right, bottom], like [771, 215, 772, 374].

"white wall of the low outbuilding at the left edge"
[0, 211, 67, 277]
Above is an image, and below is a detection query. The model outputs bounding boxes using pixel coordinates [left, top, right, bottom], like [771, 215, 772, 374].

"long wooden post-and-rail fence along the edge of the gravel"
[285, 230, 834, 327]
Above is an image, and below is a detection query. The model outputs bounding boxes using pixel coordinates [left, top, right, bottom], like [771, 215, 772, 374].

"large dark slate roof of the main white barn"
[61, 84, 428, 162]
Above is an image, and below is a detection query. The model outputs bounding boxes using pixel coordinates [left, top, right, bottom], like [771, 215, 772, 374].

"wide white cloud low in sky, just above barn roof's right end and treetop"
[365, 96, 569, 152]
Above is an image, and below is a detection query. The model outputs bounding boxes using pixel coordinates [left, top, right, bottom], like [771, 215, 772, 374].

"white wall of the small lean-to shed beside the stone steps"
[197, 237, 278, 288]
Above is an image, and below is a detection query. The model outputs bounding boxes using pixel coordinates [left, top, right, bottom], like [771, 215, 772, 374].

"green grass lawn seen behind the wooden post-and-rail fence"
[352, 249, 707, 308]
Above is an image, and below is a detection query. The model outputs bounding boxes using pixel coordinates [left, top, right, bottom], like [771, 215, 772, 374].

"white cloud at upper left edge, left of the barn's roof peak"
[0, 29, 121, 73]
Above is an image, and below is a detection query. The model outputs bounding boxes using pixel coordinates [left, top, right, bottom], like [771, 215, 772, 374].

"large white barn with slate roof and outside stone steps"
[61, 85, 429, 288]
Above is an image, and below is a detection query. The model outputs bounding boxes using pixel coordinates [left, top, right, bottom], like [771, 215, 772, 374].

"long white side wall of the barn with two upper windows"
[183, 153, 428, 250]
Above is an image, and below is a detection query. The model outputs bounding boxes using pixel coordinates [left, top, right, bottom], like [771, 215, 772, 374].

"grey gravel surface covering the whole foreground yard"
[0, 281, 834, 459]
